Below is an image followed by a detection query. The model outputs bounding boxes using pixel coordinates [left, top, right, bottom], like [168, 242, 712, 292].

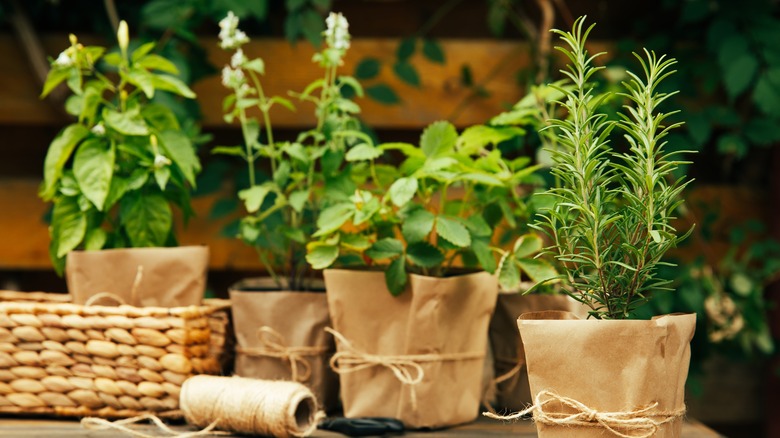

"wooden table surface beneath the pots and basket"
[0, 417, 721, 438]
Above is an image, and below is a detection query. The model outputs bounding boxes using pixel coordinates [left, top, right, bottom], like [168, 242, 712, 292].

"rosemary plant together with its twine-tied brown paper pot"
[488, 17, 696, 437]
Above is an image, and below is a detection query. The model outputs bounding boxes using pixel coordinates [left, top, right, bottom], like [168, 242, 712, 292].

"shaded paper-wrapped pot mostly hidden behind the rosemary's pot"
[489, 293, 580, 412]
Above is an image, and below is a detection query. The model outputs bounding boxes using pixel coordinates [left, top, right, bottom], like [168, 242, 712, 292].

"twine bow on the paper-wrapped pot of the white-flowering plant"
[236, 326, 328, 382]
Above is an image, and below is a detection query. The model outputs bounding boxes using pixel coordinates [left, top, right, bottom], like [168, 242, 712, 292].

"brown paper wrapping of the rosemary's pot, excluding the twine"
[517, 311, 696, 438]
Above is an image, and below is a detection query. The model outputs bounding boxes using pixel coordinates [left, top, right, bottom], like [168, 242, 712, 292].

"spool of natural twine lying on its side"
[179, 375, 319, 437]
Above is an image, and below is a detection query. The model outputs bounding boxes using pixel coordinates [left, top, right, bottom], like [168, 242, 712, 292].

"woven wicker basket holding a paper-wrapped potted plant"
[0, 291, 225, 418]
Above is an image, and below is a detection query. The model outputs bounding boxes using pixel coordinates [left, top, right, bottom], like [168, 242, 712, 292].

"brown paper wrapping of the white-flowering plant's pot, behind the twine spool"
[230, 278, 338, 412]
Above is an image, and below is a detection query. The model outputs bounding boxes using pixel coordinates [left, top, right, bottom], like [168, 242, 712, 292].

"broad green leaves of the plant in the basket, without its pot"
[39, 21, 200, 273]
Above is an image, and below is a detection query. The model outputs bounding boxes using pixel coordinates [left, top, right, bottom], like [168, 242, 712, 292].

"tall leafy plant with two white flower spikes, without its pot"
[213, 13, 363, 290]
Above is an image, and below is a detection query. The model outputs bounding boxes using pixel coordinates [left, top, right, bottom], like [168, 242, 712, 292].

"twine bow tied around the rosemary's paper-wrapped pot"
[482, 391, 685, 438]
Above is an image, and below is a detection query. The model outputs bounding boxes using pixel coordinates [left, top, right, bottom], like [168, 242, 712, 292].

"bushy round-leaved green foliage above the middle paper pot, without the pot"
[307, 121, 536, 295]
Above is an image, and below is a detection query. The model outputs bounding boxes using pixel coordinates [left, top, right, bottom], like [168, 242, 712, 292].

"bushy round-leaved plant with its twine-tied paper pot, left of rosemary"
[307, 110, 535, 428]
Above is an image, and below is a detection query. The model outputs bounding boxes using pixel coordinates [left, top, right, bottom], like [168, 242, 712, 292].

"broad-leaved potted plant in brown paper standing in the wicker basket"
[39, 21, 208, 306]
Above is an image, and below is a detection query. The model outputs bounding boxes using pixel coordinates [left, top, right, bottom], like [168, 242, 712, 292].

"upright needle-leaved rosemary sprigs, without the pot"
[537, 17, 690, 319]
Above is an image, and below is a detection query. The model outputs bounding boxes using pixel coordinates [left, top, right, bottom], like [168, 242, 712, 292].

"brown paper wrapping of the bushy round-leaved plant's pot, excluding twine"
[324, 270, 498, 428]
